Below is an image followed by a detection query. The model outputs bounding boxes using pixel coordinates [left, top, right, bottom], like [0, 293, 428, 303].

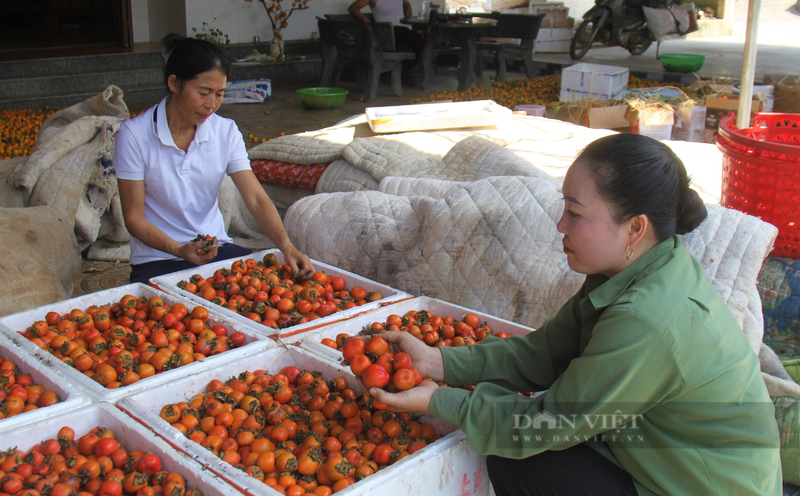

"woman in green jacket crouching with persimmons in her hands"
[371, 134, 781, 496]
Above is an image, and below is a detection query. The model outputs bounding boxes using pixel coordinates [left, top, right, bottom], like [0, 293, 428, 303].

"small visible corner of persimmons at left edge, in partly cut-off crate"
[0, 357, 58, 419]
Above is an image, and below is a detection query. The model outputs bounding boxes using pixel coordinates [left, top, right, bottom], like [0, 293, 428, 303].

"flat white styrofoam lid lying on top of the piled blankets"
[366, 100, 511, 133]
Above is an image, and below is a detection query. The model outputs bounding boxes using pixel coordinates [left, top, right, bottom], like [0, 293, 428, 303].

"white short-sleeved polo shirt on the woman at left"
[114, 97, 250, 264]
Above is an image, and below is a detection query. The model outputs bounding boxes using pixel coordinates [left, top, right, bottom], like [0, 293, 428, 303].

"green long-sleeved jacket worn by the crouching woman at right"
[430, 237, 781, 496]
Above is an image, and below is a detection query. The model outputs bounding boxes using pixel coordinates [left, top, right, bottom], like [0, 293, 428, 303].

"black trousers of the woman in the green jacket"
[486, 444, 637, 496]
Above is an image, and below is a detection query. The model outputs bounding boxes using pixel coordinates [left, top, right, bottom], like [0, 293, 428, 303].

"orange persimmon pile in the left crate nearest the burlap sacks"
[20, 295, 245, 389]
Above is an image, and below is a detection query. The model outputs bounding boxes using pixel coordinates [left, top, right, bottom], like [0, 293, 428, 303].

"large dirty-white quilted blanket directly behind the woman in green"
[285, 169, 777, 352]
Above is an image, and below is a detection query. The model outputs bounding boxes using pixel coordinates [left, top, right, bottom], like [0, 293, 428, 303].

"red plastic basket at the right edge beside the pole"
[717, 113, 800, 258]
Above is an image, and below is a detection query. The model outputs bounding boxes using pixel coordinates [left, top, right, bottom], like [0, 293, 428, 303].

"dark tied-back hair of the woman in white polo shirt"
[161, 33, 231, 87]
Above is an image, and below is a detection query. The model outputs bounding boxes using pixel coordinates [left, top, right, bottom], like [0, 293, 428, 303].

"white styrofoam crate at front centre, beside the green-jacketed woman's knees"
[119, 346, 489, 496]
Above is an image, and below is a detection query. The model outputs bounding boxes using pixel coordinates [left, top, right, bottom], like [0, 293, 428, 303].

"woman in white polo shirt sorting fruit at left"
[114, 35, 314, 283]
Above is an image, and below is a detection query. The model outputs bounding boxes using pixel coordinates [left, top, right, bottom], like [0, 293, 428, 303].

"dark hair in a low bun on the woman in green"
[575, 134, 708, 241]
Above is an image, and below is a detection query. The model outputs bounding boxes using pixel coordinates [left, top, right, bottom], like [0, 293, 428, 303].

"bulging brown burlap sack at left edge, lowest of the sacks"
[0, 206, 81, 316]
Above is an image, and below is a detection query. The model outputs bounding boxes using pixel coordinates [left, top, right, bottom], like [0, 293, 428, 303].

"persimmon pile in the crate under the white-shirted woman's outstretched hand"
[178, 253, 383, 329]
